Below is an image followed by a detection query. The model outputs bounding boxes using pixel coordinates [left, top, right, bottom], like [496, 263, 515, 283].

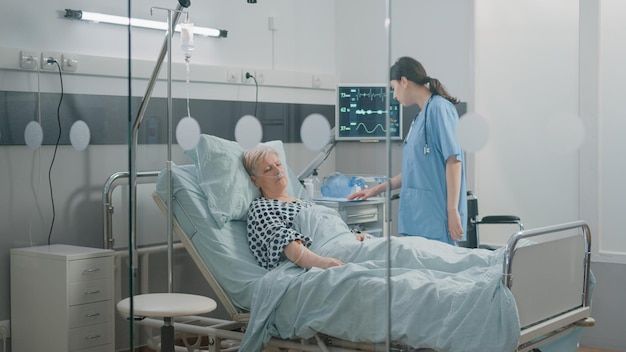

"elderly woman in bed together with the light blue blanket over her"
[240, 145, 520, 352]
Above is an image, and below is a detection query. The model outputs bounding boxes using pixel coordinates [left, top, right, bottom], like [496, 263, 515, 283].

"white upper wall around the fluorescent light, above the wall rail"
[0, 0, 335, 73]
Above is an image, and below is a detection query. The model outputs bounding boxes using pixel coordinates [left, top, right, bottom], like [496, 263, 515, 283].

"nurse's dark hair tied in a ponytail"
[389, 56, 459, 104]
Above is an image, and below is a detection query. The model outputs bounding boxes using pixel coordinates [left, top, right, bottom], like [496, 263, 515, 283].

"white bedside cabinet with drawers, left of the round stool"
[11, 244, 115, 352]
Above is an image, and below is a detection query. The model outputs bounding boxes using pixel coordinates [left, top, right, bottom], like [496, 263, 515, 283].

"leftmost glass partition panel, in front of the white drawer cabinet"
[0, 1, 133, 351]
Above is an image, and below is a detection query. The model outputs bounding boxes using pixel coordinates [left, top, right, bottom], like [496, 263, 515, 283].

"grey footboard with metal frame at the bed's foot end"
[502, 221, 593, 351]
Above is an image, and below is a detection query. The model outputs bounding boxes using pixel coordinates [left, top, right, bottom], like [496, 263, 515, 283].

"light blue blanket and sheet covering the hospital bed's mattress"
[157, 165, 595, 352]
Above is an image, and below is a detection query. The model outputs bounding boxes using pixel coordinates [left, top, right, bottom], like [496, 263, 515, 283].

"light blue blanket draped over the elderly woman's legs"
[240, 206, 520, 352]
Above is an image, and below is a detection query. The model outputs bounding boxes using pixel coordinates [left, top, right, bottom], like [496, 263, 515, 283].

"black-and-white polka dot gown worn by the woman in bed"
[248, 197, 315, 270]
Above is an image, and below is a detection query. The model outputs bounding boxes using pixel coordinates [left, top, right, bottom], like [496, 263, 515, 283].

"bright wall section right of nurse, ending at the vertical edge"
[474, 0, 579, 239]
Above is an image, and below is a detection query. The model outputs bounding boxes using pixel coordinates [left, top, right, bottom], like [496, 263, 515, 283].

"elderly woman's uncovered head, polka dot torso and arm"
[244, 146, 366, 269]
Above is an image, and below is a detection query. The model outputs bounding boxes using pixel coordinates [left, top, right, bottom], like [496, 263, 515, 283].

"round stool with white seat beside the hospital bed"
[117, 293, 217, 352]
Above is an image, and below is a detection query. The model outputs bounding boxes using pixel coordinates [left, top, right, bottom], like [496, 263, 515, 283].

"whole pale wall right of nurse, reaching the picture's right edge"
[475, 0, 626, 263]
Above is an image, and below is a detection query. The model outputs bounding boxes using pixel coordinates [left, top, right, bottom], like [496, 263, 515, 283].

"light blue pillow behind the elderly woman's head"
[185, 134, 306, 228]
